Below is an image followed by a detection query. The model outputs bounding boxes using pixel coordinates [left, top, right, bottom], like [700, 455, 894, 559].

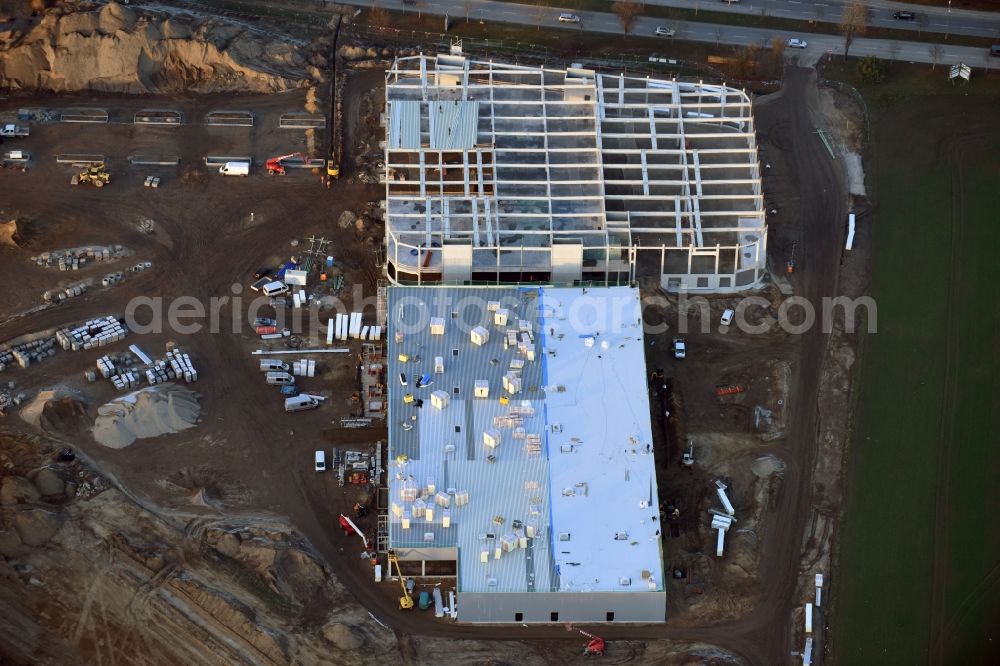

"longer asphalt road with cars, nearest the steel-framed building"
[350, 0, 1000, 69]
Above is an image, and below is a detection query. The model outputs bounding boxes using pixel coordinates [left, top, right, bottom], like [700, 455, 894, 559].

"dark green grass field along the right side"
[831, 68, 1000, 664]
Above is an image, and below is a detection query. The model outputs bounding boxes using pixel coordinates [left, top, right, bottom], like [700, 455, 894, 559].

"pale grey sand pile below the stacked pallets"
[93, 383, 201, 449]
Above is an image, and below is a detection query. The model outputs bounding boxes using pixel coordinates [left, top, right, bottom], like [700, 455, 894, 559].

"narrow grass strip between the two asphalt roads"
[492, 0, 995, 48]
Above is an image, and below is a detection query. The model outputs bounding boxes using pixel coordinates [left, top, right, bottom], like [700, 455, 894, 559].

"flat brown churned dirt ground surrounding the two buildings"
[0, 46, 864, 663]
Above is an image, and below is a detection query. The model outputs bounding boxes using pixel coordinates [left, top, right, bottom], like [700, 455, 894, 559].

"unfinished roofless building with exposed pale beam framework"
[384, 55, 767, 292]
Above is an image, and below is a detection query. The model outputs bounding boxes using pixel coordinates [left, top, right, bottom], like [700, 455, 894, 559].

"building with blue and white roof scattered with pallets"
[387, 287, 666, 623]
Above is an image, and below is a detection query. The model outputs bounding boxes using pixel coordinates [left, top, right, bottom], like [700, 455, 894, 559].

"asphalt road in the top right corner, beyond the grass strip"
[645, 0, 1000, 42]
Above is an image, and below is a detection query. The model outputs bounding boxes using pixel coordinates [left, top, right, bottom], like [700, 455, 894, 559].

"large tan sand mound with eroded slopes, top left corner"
[0, 2, 323, 94]
